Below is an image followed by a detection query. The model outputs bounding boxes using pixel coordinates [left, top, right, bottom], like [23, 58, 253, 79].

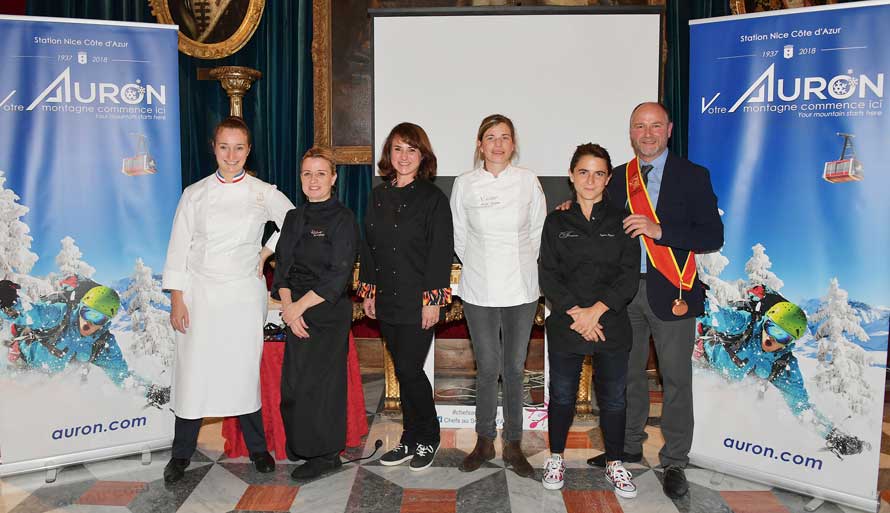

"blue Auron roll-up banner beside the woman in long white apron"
[0, 16, 181, 475]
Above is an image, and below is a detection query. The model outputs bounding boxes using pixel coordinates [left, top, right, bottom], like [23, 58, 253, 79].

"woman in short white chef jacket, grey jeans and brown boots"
[451, 114, 547, 477]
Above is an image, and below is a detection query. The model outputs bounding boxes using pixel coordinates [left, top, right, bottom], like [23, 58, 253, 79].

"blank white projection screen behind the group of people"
[369, 8, 661, 179]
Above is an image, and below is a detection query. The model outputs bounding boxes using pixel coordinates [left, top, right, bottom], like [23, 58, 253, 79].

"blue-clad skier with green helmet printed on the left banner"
[0, 276, 170, 407]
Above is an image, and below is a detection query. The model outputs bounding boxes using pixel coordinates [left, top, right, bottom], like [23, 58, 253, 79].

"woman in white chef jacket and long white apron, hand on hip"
[163, 117, 294, 483]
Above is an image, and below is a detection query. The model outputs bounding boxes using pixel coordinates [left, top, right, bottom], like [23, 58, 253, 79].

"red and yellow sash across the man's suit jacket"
[625, 157, 695, 290]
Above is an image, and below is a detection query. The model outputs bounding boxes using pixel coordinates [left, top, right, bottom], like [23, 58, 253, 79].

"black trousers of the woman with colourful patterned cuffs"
[380, 321, 439, 446]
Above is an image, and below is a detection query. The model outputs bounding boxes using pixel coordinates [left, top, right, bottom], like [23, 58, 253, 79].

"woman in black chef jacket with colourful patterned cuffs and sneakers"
[359, 123, 454, 470]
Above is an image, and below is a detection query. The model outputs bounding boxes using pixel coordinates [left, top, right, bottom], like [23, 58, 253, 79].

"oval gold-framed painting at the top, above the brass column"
[148, 0, 266, 59]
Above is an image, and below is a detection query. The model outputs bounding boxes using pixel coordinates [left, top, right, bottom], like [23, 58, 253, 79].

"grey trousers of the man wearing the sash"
[624, 280, 695, 467]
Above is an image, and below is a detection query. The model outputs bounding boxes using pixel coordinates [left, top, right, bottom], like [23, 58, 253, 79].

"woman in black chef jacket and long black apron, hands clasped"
[272, 147, 358, 479]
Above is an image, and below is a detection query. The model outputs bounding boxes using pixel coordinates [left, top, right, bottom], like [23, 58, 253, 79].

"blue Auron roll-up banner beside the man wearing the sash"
[689, 1, 890, 511]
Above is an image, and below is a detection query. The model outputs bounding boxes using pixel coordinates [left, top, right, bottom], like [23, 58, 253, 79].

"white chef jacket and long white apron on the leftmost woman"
[163, 173, 294, 419]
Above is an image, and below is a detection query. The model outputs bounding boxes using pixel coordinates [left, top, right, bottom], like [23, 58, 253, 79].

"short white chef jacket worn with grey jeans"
[451, 166, 547, 307]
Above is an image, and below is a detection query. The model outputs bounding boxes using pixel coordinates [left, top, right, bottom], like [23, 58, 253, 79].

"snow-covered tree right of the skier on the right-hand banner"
[810, 278, 874, 413]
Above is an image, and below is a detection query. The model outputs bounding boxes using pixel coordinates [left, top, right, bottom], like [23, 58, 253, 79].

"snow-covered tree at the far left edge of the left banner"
[0, 171, 50, 302]
